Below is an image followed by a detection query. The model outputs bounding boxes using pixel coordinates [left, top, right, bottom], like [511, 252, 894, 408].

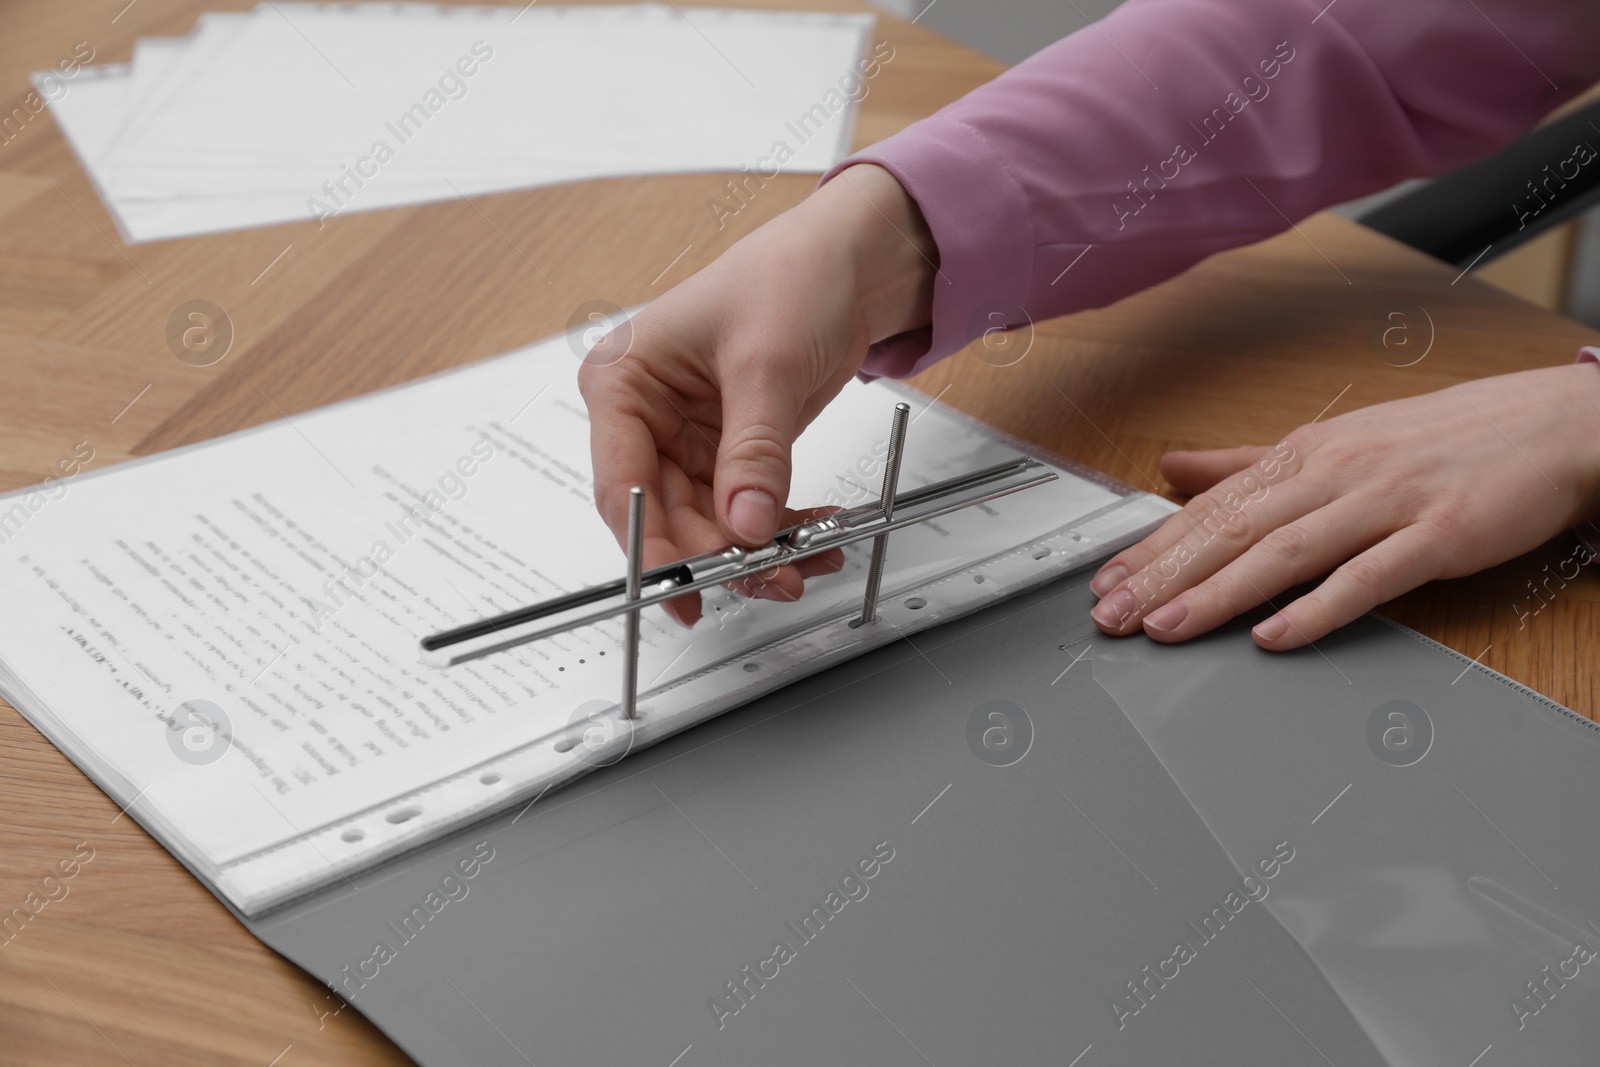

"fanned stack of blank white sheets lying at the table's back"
[35, 2, 885, 242]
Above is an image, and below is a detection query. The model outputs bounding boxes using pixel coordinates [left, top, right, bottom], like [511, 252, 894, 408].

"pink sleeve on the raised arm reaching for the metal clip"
[824, 0, 1600, 378]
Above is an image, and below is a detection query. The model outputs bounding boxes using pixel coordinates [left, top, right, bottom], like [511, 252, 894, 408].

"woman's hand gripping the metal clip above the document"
[578, 165, 936, 625]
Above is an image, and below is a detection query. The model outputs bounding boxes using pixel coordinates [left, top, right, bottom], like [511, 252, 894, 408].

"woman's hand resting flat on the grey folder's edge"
[1090, 363, 1600, 651]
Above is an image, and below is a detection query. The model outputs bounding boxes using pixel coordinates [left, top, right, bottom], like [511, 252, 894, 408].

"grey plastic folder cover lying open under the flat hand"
[250, 577, 1600, 1067]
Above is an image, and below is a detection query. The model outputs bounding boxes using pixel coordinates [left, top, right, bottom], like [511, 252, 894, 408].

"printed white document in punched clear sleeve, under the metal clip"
[0, 321, 1171, 913]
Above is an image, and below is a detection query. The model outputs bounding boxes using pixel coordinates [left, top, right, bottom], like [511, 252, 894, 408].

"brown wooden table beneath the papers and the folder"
[0, 0, 1600, 1067]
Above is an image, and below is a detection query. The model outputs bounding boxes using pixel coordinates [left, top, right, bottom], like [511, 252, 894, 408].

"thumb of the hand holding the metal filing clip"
[714, 374, 802, 545]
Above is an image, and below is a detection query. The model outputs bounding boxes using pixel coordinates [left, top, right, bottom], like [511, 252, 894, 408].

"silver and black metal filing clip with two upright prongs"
[422, 403, 1056, 720]
